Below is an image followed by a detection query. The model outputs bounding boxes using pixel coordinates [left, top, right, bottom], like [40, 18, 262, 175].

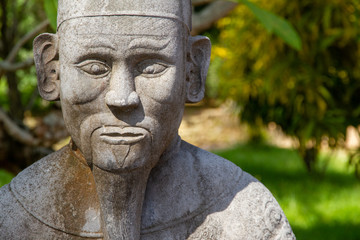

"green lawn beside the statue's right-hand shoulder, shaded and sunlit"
[217, 145, 360, 240]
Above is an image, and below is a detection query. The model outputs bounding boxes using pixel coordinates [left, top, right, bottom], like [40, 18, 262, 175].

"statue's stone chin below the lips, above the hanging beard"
[90, 127, 154, 172]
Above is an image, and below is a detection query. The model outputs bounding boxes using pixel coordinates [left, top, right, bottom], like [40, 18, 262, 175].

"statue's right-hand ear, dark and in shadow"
[186, 36, 211, 103]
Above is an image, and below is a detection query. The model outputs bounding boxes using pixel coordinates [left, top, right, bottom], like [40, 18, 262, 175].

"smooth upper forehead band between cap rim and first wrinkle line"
[58, 16, 187, 37]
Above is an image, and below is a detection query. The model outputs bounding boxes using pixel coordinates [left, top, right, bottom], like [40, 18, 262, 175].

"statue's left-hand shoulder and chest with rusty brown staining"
[0, 146, 101, 237]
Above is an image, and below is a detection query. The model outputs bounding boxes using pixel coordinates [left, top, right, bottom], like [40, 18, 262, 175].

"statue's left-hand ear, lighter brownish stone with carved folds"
[34, 33, 60, 101]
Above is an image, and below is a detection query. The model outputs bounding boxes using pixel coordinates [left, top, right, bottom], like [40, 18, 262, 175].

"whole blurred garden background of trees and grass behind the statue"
[0, 0, 360, 239]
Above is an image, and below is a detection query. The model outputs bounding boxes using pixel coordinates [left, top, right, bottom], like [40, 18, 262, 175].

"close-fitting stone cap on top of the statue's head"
[58, 0, 191, 29]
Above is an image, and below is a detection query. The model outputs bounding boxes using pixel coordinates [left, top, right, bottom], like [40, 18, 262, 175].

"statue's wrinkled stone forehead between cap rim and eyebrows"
[58, 16, 184, 56]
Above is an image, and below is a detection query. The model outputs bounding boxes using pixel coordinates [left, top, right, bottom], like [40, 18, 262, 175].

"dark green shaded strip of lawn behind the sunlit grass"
[216, 144, 359, 188]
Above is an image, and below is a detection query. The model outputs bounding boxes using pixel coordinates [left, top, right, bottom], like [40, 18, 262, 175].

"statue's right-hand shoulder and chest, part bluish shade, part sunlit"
[143, 141, 294, 239]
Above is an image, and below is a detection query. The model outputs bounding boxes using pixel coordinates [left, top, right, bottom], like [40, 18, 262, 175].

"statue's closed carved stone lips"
[100, 126, 149, 145]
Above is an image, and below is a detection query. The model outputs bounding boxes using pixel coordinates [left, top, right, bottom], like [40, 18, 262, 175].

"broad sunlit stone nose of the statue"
[105, 67, 140, 111]
